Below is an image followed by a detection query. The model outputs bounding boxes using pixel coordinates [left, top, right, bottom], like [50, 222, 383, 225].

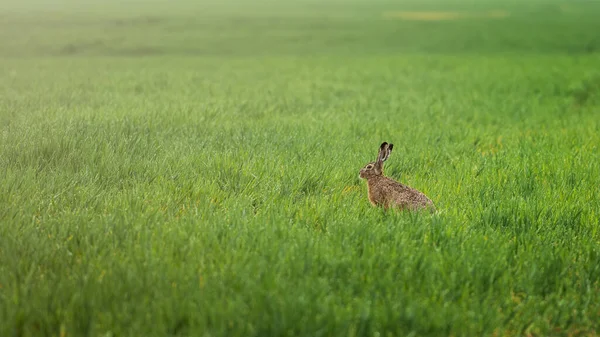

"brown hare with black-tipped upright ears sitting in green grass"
[359, 142, 435, 212]
